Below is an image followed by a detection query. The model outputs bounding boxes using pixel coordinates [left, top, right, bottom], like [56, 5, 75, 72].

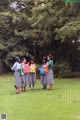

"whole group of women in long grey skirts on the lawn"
[12, 55, 54, 94]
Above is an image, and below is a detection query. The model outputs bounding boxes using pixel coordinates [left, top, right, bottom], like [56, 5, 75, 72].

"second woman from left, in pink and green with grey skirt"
[21, 58, 29, 92]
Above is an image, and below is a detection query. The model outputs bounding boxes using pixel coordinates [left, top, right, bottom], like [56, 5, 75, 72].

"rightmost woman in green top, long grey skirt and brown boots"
[47, 54, 54, 90]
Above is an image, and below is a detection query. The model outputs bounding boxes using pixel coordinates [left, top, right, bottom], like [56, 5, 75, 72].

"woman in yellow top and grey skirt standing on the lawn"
[29, 59, 36, 89]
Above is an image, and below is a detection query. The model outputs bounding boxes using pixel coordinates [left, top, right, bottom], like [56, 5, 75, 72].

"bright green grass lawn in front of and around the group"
[0, 75, 80, 120]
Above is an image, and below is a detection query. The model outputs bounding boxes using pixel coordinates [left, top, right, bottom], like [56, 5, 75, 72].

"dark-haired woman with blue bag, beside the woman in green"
[39, 57, 49, 89]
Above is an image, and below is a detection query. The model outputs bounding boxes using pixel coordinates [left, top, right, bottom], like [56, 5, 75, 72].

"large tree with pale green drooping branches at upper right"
[33, 0, 80, 70]
